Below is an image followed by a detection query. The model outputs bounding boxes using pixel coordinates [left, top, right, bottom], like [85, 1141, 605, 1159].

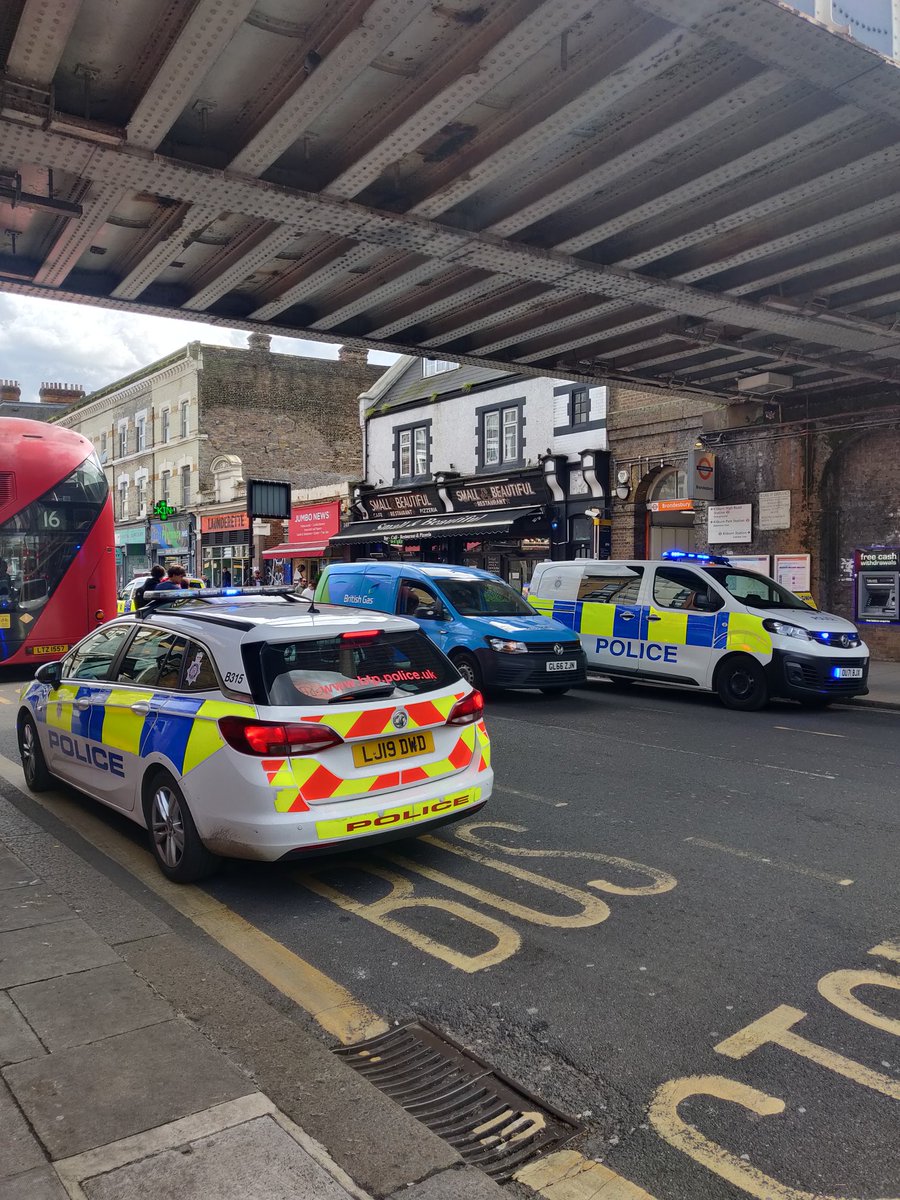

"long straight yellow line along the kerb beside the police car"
[0, 755, 390, 1045]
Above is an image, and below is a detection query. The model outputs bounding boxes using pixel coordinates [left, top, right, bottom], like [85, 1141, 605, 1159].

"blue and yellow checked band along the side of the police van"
[528, 596, 772, 655]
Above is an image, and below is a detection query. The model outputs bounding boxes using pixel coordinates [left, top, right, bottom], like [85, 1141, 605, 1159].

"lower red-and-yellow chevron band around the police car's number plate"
[263, 722, 490, 812]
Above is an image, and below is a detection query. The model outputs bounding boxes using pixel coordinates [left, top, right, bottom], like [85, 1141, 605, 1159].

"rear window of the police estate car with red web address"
[244, 630, 460, 707]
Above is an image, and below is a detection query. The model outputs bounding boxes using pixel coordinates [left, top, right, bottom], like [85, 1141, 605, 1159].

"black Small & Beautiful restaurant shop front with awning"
[331, 469, 554, 587]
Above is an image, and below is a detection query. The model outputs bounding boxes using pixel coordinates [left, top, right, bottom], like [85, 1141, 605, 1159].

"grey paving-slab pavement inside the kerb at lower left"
[0, 833, 503, 1200]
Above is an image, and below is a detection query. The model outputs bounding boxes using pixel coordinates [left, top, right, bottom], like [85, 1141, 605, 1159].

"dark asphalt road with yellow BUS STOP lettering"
[0, 684, 900, 1200]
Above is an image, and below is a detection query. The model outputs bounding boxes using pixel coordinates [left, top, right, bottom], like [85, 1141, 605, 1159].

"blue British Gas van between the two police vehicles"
[316, 563, 587, 694]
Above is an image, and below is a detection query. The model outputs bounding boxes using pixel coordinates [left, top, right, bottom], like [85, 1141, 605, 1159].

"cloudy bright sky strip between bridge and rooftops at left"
[0, 293, 397, 401]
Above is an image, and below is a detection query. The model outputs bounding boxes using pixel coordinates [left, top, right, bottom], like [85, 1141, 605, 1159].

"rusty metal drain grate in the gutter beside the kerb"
[335, 1021, 580, 1183]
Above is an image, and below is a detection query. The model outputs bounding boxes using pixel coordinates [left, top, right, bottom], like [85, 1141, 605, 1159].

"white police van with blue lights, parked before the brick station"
[529, 551, 869, 710]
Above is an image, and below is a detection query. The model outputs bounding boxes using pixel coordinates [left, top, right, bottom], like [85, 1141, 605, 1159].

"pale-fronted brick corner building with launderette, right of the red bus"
[60, 334, 382, 583]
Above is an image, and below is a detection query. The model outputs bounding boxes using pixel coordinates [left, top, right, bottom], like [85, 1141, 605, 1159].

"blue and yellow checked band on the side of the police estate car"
[26, 683, 257, 775]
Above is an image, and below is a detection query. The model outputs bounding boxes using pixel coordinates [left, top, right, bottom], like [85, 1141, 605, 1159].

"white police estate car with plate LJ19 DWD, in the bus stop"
[17, 588, 493, 882]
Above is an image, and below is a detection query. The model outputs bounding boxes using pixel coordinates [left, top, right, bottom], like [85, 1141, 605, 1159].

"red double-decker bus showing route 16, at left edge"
[0, 416, 115, 667]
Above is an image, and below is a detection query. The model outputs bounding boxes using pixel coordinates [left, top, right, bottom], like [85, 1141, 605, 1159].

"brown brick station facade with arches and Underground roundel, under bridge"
[608, 386, 900, 661]
